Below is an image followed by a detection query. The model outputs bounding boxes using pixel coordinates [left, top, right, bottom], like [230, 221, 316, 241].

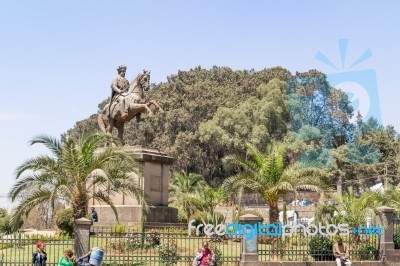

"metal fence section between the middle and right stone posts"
[258, 230, 381, 261]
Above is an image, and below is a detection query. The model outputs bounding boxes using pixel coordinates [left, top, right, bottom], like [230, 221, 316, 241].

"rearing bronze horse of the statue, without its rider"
[97, 70, 164, 144]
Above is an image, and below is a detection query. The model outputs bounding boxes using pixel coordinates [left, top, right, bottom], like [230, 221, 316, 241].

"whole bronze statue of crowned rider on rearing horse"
[97, 65, 164, 144]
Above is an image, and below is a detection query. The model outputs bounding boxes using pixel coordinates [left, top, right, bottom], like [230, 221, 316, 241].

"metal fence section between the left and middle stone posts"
[90, 228, 241, 266]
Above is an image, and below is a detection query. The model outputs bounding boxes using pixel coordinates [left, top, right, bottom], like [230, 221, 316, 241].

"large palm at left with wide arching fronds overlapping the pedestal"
[9, 134, 148, 227]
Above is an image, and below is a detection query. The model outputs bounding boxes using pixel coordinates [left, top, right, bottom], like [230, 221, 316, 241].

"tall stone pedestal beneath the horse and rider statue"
[89, 146, 178, 226]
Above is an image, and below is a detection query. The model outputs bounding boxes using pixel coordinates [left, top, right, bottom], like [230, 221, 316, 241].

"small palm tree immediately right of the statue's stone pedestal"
[169, 171, 207, 219]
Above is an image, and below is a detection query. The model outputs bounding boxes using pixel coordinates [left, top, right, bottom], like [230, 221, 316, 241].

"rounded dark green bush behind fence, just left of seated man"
[308, 235, 334, 261]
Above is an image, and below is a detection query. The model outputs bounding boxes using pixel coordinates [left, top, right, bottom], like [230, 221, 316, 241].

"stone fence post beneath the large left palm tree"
[74, 217, 92, 257]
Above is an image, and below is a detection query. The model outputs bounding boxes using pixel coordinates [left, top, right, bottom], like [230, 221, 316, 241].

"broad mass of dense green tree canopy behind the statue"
[64, 67, 400, 191]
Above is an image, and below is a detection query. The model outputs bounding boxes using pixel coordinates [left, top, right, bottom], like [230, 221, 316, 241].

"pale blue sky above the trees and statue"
[0, 0, 400, 207]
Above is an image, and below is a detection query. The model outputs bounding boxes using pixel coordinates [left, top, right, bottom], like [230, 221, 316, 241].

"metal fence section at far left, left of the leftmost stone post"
[0, 233, 74, 266]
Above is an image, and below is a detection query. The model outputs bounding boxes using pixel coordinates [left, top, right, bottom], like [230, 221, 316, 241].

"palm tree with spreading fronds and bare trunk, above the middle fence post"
[223, 144, 319, 224]
